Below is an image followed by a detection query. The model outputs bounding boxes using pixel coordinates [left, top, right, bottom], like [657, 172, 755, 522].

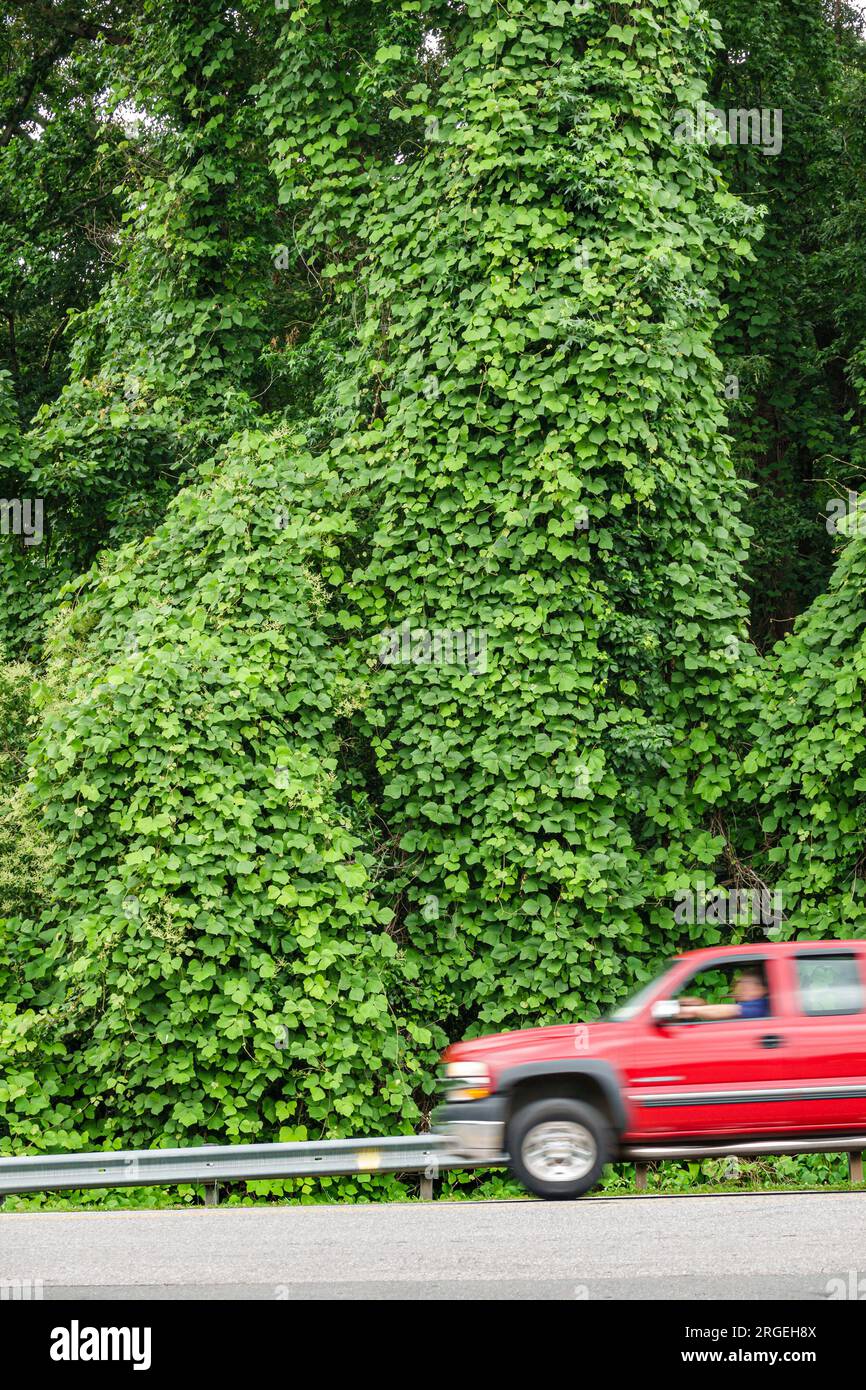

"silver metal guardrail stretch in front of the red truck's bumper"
[0, 1134, 492, 1204]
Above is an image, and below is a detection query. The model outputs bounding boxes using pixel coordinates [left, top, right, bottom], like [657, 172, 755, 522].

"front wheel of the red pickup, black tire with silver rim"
[507, 1097, 613, 1201]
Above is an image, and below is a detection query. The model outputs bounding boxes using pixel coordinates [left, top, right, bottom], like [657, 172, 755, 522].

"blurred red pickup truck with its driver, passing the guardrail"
[434, 941, 866, 1200]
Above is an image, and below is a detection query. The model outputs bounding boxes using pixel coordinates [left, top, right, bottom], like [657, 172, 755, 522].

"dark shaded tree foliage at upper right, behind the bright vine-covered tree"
[710, 0, 866, 649]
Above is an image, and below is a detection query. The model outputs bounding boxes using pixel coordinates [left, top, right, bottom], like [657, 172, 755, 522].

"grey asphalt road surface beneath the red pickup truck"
[0, 1193, 866, 1301]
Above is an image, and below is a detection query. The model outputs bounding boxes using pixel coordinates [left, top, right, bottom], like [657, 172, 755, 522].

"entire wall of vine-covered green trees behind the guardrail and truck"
[0, 0, 866, 1191]
